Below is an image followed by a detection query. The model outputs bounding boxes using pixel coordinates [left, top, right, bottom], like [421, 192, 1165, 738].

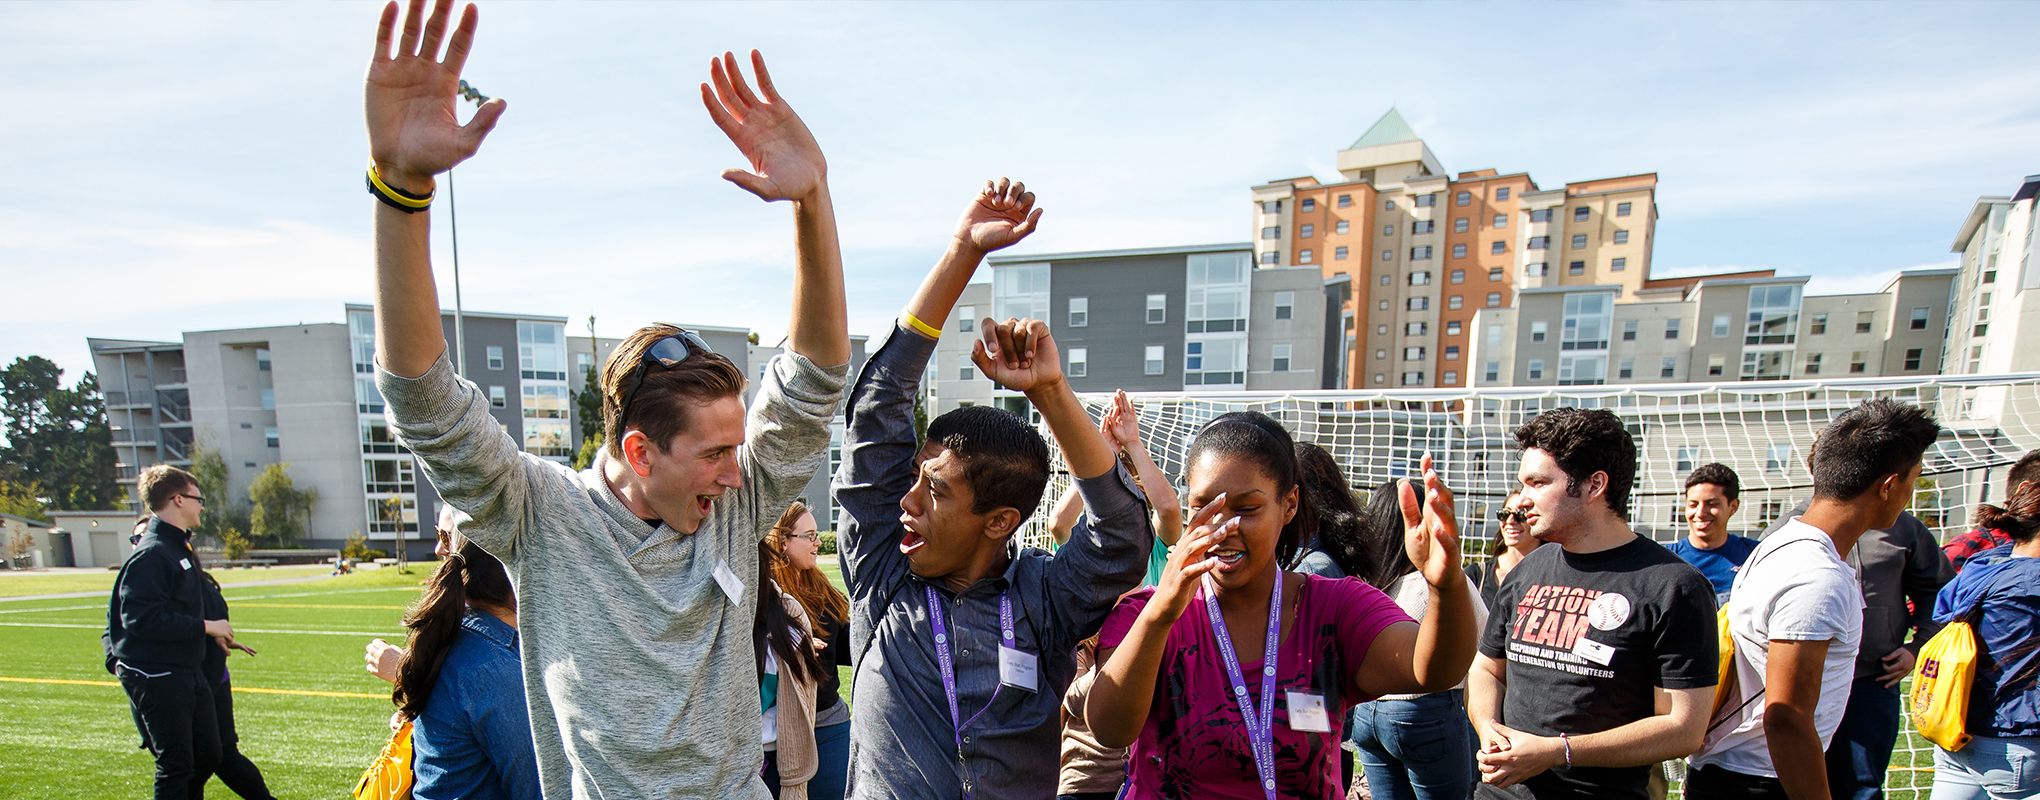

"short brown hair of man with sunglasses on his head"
[602, 322, 745, 459]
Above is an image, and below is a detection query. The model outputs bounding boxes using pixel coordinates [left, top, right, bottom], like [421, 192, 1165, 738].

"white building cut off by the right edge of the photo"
[1944, 176, 2040, 373]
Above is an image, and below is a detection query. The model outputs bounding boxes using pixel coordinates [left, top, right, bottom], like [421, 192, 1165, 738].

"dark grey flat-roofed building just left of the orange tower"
[979, 243, 1336, 410]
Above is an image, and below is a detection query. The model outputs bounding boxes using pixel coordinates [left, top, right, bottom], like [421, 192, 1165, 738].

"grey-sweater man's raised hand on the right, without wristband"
[702, 51, 828, 200]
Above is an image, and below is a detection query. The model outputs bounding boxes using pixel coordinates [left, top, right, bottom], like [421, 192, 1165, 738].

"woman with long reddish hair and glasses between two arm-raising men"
[757, 500, 851, 800]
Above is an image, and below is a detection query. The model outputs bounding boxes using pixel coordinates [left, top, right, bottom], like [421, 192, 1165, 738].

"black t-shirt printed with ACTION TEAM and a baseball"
[1481, 537, 1718, 800]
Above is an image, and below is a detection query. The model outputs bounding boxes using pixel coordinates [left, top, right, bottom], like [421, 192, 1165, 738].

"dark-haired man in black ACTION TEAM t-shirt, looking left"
[1467, 408, 1718, 800]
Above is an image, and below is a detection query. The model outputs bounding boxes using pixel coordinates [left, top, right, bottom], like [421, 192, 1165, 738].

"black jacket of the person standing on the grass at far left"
[106, 520, 206, 673]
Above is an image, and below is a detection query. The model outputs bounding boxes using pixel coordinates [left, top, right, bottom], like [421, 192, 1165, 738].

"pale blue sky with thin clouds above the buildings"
[0, 2, 2040, 380]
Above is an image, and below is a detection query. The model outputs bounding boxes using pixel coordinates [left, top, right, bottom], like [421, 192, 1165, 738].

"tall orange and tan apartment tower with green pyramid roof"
[1253, 108, 1656, 388]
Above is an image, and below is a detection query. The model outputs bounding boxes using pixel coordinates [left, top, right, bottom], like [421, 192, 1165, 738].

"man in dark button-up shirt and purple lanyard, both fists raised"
[832, 182, 1155, 800]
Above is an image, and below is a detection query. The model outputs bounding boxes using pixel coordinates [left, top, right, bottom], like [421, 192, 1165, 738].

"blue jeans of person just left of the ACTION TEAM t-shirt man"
[1353, 690, 1475, 800]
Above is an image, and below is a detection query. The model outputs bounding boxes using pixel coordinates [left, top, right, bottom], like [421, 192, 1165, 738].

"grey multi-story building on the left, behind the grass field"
[88, 304, 751, 557]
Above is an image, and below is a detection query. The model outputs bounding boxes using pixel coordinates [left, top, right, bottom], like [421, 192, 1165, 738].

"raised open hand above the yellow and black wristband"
[367, 0, 508, 192]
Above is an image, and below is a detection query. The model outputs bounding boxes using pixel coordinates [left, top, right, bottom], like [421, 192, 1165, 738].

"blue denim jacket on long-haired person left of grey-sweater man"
[410, 608, 539, 800]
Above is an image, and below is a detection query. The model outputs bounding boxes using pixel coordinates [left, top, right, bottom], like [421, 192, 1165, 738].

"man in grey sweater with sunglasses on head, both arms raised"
[367, 0, 849, 800]
